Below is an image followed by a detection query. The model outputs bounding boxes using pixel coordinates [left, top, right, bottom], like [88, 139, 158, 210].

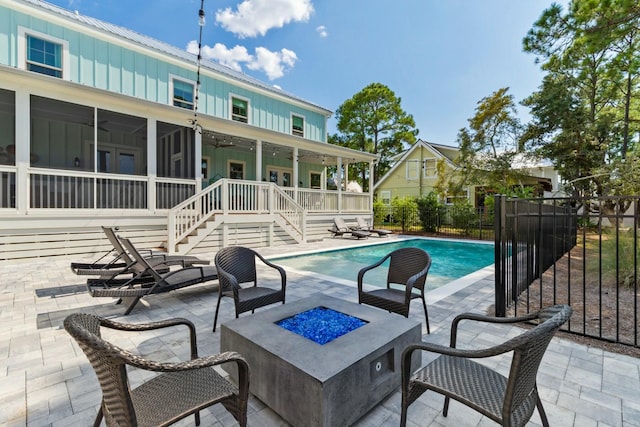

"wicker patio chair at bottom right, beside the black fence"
[400, 305, 572, 426]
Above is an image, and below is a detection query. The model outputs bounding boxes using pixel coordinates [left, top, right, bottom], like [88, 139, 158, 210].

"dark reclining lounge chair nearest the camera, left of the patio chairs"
[87, 239, 218, 315]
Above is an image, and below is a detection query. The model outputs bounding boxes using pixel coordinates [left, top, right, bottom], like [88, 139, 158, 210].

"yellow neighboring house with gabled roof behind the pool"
[373, 139, 468, 205]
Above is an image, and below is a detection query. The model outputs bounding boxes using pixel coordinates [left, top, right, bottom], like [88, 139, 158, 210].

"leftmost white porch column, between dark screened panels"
[14, 90, 31, 215]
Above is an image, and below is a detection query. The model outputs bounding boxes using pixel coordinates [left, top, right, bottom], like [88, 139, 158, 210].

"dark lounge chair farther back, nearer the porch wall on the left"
[71, 227, 210, 283]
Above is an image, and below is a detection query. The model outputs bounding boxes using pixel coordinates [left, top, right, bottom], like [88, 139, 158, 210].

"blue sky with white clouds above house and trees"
[49, 0, 565, 146]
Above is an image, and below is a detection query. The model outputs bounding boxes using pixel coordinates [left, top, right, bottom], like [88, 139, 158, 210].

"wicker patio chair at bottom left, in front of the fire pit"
[64, 313, 249, 426]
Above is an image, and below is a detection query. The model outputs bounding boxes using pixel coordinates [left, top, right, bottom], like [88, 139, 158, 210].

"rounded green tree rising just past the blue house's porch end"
[329, 83, 418, 188]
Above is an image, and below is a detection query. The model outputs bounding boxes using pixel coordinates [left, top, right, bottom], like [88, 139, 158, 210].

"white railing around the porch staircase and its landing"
[167, 178, 305, 252]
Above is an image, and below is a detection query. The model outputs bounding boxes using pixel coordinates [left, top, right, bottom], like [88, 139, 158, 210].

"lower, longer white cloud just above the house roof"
[187, 40, 298, 80]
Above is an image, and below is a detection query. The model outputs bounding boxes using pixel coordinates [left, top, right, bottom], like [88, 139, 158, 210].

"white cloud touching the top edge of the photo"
[216, 0, 314, 39]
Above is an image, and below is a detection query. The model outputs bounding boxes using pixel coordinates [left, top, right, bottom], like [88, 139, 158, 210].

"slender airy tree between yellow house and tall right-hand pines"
[449, 88, 523, 195]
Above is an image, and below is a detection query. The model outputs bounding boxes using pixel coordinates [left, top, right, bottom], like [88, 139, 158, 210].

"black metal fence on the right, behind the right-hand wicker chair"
[495, 196, 640, 347]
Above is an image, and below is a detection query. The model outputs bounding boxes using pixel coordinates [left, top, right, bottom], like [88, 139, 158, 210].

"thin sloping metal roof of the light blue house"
[14, 0, 333, 115]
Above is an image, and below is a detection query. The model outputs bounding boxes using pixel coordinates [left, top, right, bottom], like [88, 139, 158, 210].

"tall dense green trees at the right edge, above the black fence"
[522, 0, 640, 210]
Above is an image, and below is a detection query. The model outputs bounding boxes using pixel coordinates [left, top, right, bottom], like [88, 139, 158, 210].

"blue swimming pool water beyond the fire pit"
[271, 239, 494, 289]
